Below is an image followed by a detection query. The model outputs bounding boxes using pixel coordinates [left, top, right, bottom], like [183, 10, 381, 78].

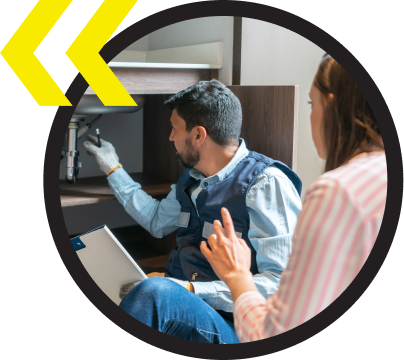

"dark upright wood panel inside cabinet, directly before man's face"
[143, 95, 184, 184]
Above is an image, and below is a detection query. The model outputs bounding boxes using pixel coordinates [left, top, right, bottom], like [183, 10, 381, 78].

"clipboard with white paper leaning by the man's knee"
[70, 225, 147, 305]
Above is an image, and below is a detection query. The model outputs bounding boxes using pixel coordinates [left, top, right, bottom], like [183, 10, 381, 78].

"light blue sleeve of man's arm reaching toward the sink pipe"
[107, 168, 181, 238]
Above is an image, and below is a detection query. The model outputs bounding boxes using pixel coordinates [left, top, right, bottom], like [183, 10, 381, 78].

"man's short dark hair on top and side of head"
[164, 79, 242, 146]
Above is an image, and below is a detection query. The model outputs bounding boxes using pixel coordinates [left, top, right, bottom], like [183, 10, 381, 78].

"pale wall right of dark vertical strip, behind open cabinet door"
[241, 18, 325, 197]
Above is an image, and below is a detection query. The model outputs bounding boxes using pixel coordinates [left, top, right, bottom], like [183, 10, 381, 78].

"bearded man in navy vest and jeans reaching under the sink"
[84, 80, 302, 344]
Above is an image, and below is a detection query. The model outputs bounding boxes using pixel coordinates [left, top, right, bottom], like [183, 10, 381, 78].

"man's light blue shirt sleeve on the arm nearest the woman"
[247, 166, 302, 282]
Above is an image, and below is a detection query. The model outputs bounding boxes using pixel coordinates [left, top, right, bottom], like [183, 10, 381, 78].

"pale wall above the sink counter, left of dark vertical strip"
[148, 16, 233, 85]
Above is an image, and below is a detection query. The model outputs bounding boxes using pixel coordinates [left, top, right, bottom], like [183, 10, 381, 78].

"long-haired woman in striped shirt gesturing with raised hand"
[201, 54, 387, 342]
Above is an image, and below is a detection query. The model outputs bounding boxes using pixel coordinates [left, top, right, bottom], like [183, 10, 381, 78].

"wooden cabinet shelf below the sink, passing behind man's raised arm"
[59, 172, 173, 207]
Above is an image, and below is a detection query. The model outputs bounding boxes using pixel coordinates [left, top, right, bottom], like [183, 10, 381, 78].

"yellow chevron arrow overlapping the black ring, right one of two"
[66, 0, 137, 106]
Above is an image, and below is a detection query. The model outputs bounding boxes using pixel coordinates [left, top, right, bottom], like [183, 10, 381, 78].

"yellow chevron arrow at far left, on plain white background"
[0, 0, 73, 106]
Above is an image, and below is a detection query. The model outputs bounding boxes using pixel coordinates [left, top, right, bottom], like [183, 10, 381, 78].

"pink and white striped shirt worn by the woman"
[234, 152, 387, 342]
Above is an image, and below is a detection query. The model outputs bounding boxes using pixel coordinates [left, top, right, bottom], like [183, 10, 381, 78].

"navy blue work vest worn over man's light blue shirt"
[165, 151, 302, 281]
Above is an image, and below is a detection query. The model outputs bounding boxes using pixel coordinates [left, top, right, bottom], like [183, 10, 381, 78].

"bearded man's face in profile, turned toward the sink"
[169, 108, 200, 168]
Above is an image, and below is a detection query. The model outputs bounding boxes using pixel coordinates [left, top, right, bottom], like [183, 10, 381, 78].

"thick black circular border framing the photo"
[43, 1, 404, 358]
